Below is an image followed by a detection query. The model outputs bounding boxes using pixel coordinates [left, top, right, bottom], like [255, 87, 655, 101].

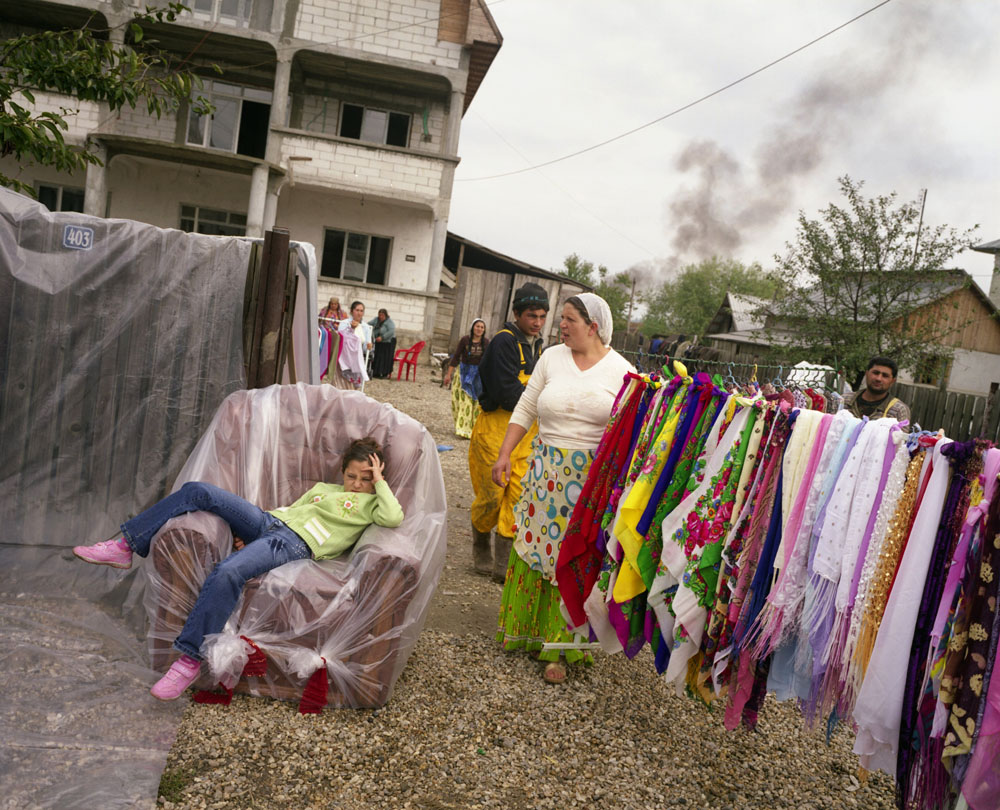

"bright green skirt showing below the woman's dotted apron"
[496, 549, 594, 664]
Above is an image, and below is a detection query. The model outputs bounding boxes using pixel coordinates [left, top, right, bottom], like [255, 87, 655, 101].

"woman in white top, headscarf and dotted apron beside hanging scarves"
[493, 293, 635, 683]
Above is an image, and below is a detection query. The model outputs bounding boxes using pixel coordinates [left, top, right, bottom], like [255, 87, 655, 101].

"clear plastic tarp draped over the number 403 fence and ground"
[0, 189, 251, 810]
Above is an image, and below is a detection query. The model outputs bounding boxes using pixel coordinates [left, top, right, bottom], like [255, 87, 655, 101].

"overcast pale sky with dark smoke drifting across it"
[449, 0, 1000, 288]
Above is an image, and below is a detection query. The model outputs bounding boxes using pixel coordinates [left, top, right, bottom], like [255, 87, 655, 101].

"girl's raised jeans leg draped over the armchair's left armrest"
[122, 481, 273, 557]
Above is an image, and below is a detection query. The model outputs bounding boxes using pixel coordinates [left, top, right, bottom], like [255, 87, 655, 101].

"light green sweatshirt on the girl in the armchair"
[270, 480, 403, 560]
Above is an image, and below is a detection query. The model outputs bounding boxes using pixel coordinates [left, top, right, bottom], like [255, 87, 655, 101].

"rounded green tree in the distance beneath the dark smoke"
[643, 256, 778, 335]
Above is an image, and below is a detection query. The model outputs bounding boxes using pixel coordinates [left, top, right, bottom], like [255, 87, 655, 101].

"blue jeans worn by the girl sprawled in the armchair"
[122, 482, 312, 661]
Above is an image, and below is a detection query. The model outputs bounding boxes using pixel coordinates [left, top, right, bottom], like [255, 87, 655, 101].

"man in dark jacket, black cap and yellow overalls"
[469, 282, 549, 582]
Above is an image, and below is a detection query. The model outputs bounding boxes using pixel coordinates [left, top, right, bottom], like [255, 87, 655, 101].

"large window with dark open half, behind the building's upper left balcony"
[187, 81, 271, 158]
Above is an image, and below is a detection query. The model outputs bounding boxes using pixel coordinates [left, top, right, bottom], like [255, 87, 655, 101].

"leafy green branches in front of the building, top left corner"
[0, 2, 211, 195]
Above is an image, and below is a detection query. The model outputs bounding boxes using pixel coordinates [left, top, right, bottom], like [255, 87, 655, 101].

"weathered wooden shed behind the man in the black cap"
[433, 232, 591, 352]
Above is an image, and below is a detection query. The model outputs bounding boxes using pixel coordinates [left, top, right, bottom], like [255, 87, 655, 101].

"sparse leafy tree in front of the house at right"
[760, 176, 976, 382]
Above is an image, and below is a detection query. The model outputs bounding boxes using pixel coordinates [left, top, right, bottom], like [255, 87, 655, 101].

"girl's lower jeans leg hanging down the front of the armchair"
[174, 515, 311, 660]
